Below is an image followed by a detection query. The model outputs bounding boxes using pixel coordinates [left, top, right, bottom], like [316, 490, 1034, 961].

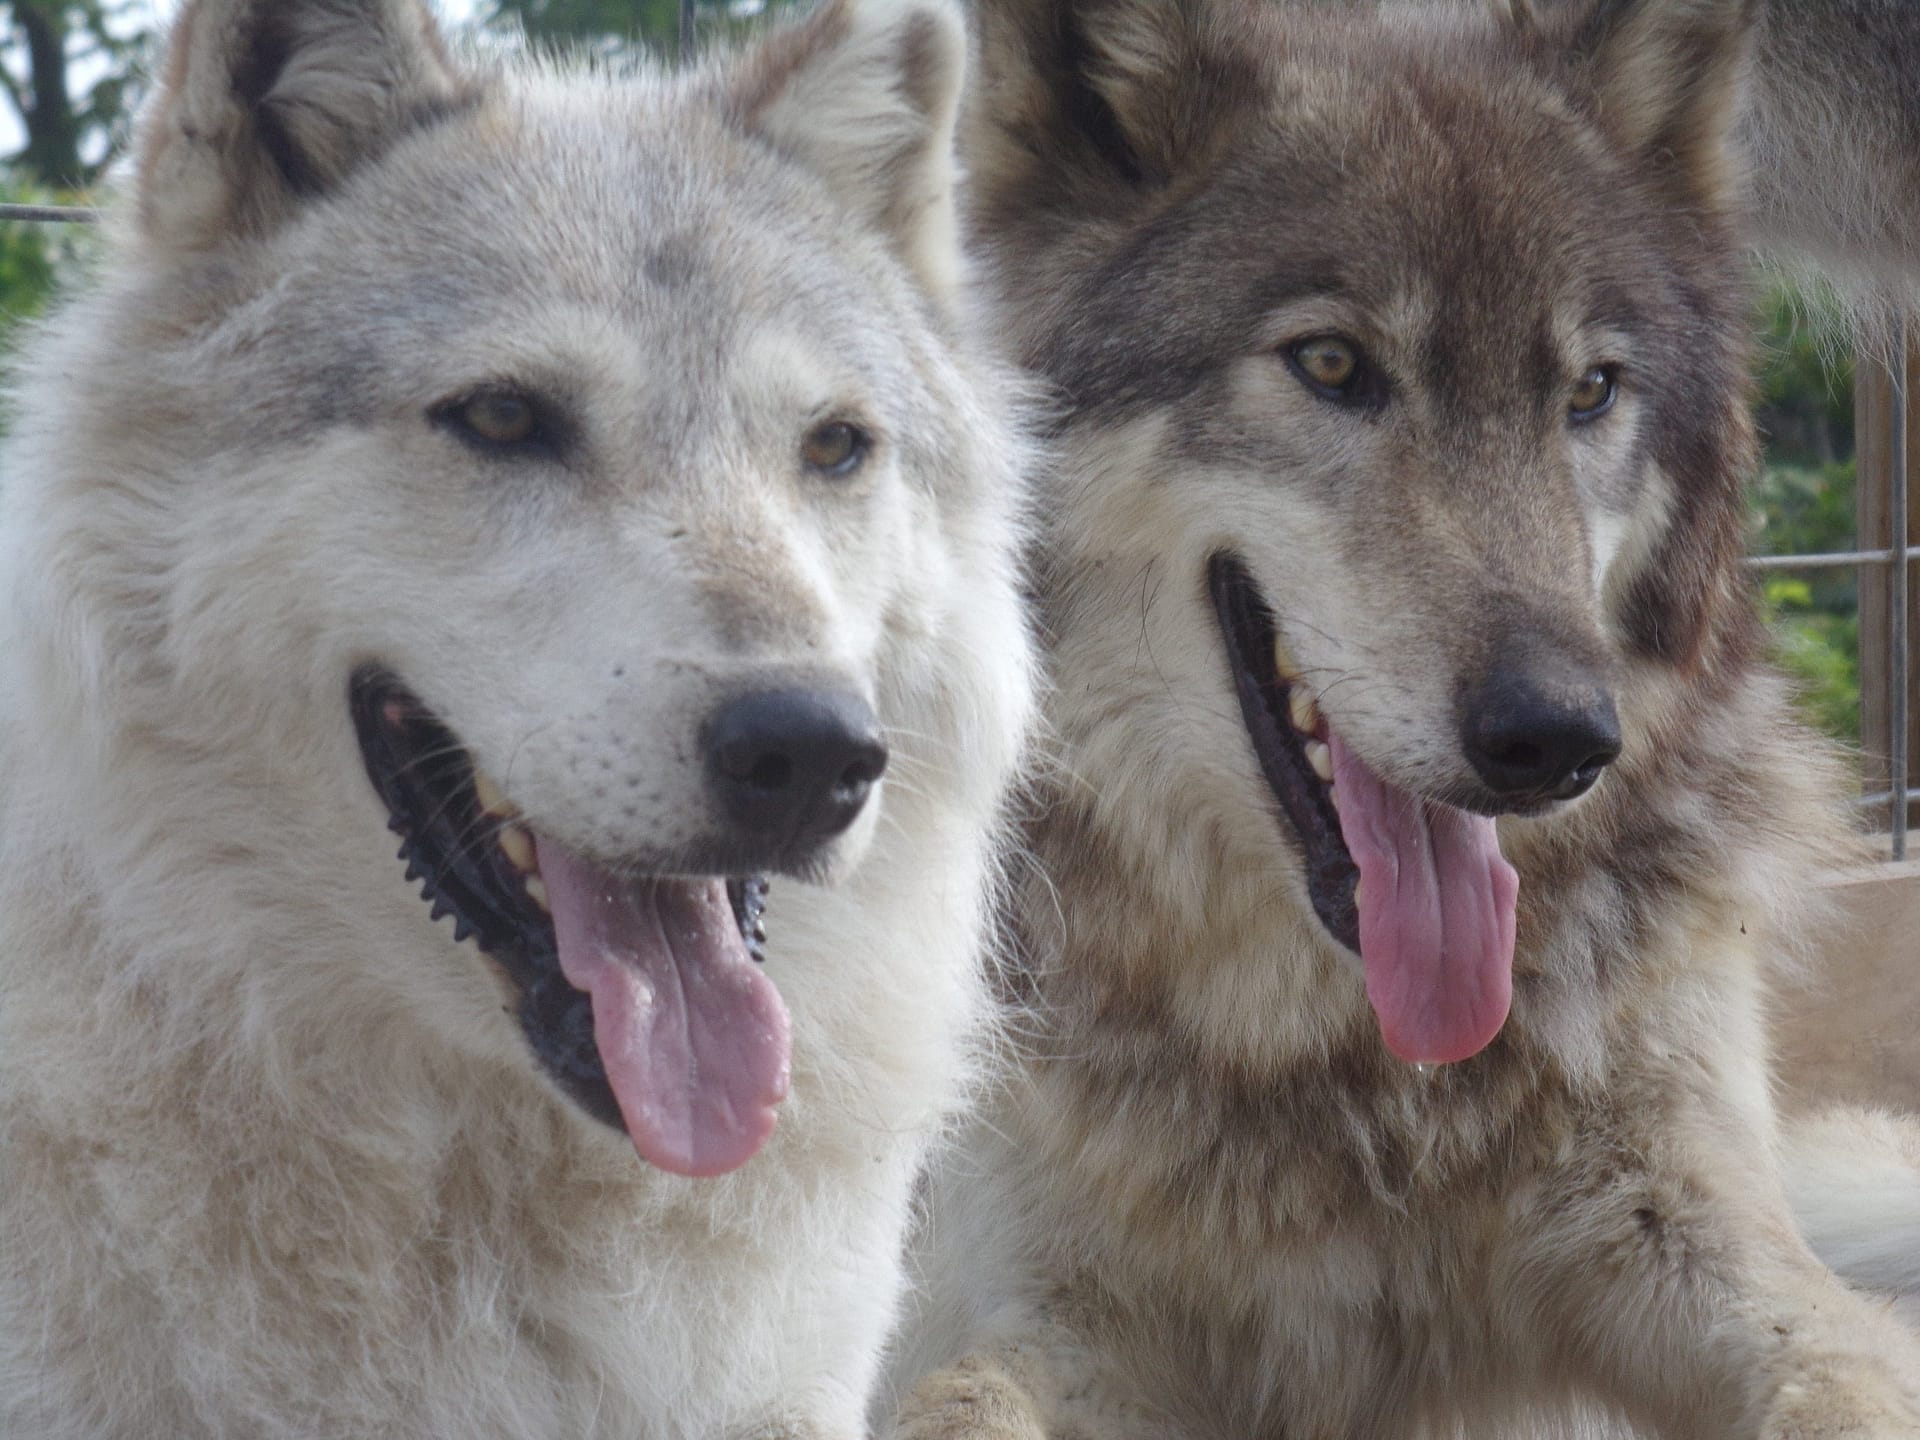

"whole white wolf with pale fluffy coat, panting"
[0, 0, 1031, 1440]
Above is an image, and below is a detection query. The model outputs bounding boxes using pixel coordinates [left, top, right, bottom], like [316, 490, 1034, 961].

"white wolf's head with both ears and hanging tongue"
[3, 0, 1025, 1173]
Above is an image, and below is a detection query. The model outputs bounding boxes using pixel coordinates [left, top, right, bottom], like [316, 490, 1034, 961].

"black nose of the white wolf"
[707, 689, 887, 847]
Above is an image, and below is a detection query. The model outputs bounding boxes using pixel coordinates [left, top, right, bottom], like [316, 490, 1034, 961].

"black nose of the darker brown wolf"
[1461, 666, 1620, 801]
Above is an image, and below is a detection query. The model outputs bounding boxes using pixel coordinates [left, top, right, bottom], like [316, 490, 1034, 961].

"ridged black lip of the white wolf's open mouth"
[348, 666, 766, 1133]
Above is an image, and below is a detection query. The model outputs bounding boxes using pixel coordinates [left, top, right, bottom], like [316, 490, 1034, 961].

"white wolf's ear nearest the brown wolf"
[730, 0, 966, 305]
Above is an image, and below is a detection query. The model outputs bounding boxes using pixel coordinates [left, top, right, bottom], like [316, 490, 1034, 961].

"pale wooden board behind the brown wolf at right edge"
[1774, 860, 1920, 1114]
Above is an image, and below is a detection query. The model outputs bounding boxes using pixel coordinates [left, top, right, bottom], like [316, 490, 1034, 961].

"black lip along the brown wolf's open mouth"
[1208, 555, 1359, 954]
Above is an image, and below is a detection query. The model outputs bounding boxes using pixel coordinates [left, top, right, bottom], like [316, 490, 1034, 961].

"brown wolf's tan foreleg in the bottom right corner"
[1505, 1114, 1920, 1440]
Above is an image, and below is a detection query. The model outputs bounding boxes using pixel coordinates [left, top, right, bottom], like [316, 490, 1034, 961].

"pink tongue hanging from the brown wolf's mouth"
[1327, 735, 1521, 1064]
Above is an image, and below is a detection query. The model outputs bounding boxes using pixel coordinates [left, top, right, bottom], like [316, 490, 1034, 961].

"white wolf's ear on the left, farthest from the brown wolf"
[136, 0, 470, 248]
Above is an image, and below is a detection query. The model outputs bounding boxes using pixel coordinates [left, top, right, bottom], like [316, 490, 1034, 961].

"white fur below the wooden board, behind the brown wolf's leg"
[1782, 1108, 1920, 1321]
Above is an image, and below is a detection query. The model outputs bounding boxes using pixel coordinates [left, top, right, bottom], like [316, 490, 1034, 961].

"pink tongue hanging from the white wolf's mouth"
[536, 839, 789, 1175]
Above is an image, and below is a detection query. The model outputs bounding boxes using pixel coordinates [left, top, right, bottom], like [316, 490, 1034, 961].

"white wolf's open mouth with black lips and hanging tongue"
[348, 666, 787, 1175]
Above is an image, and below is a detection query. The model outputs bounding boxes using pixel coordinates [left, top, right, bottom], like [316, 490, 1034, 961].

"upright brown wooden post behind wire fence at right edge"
[1853, 336, 1920, 826]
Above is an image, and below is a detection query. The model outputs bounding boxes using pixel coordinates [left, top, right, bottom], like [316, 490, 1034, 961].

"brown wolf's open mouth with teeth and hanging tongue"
[1208, 555, 1519, 1064]
